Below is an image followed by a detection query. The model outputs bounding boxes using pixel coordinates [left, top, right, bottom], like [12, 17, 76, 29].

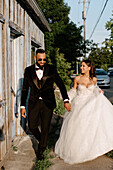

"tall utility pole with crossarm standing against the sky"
[79, 0, 89, 58]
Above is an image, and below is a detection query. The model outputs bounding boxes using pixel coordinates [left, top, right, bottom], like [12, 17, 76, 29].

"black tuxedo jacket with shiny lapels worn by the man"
[21, 64, 69, 110]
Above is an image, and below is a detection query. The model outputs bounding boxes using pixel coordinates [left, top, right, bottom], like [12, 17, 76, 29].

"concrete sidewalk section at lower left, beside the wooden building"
[0, 135, 36, 170]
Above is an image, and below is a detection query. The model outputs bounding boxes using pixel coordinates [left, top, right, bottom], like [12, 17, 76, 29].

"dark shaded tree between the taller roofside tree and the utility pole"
[55, 22, 84, 70]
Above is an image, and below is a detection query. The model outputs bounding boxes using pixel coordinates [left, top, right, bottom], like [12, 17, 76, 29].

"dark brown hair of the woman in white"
[82, 59, 96, 79]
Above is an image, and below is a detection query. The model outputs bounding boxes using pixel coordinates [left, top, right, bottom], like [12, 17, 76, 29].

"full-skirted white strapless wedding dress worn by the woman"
[55, 84, 113, 164]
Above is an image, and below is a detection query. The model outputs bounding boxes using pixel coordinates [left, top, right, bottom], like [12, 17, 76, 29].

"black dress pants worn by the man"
[28, 100, 53, 151]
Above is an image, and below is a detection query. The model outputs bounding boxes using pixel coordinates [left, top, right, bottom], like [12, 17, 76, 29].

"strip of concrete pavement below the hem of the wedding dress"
[49, 156, 113, 170]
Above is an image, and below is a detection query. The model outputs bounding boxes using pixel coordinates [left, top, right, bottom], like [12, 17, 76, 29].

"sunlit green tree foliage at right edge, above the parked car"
[89, 11, 113, 71]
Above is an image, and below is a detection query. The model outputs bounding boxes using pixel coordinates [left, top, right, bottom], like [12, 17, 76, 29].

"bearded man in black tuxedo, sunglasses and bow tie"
[20, 49, 71, 160]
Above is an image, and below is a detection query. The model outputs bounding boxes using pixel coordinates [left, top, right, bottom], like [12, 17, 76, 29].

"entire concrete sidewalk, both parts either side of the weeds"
[0, 136, 113, 170]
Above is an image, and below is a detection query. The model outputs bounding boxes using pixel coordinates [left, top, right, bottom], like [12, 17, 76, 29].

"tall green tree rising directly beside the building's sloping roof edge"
[37, 0, 70, 61]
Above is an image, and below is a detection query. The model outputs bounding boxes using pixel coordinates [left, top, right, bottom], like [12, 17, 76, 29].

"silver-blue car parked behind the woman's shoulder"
[96, 69, 110, 88]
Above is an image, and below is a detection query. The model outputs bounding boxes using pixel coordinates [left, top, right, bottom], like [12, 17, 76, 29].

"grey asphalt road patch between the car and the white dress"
[101, 77, 113, 101]
